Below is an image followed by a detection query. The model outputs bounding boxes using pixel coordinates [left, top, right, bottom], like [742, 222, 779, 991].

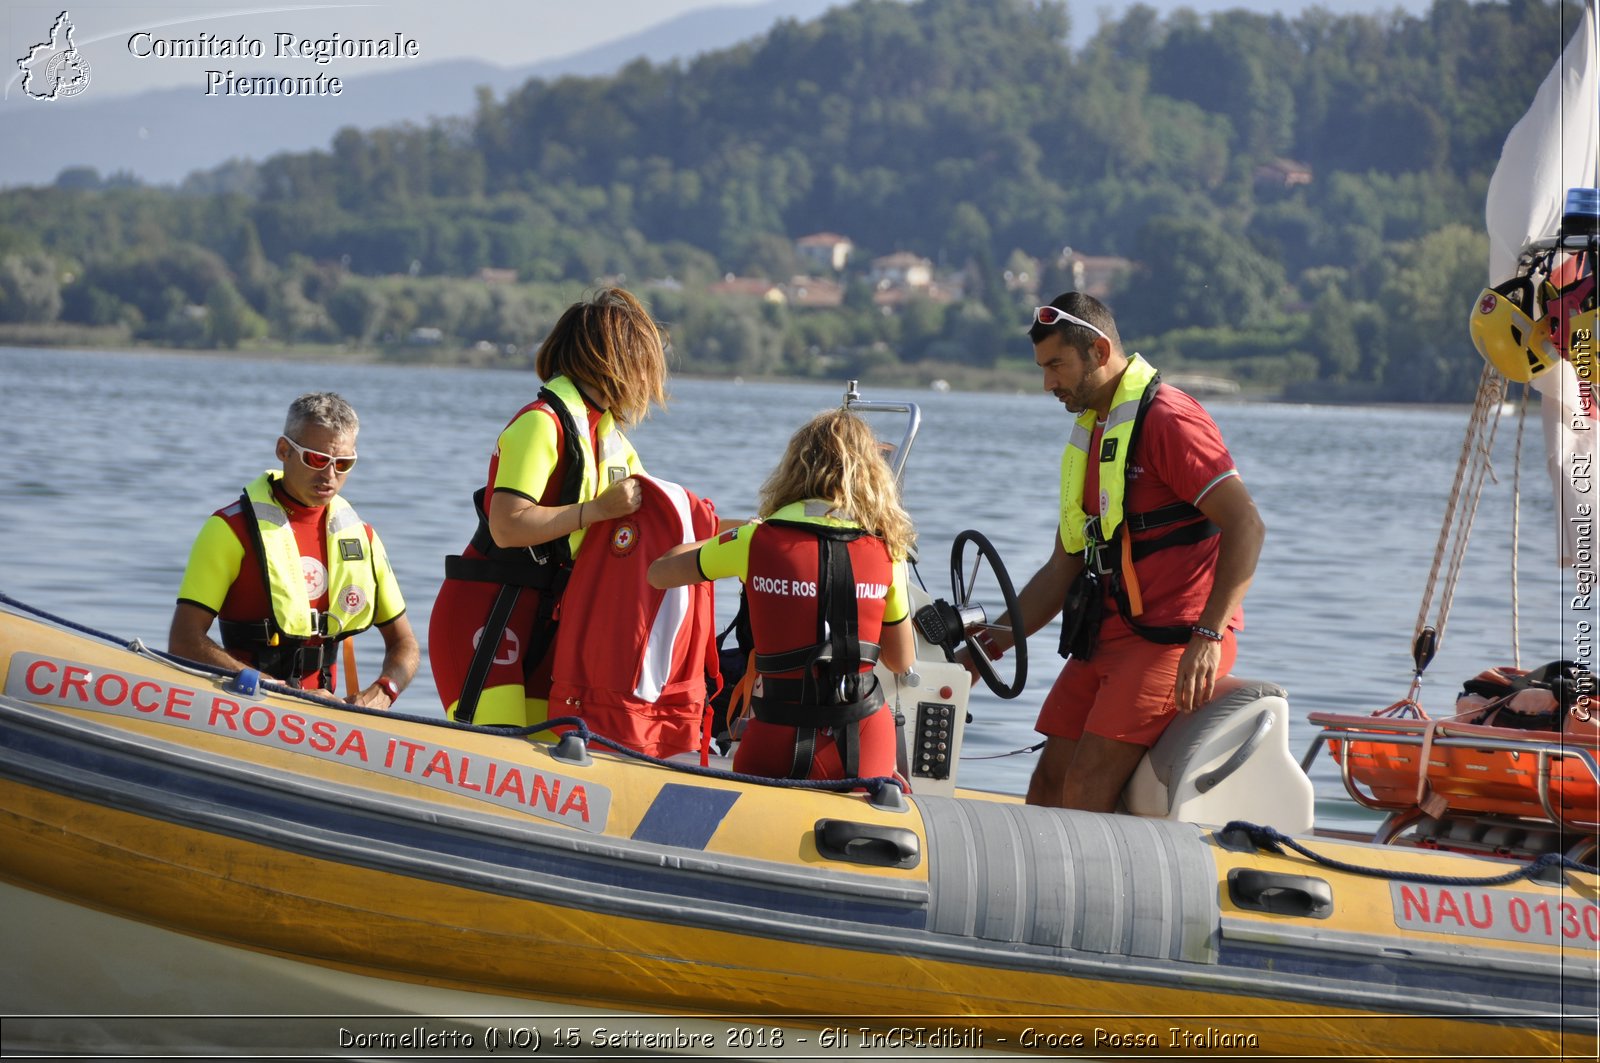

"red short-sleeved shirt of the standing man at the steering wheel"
[1083, 384, 1245, 637]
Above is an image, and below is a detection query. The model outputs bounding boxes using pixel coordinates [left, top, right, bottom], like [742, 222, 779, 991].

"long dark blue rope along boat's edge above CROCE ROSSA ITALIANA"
[0, 591, 899, 797]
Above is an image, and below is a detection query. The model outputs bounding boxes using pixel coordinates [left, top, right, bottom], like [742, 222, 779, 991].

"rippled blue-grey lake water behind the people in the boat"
[0, 347, 1574, 823]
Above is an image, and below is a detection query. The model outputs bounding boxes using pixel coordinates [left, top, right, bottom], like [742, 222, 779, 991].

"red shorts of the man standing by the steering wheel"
[1034, 629, 1238, 748]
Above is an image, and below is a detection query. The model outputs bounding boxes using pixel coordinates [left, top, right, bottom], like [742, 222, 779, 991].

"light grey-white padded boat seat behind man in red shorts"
[1122, 676, 1317, 834]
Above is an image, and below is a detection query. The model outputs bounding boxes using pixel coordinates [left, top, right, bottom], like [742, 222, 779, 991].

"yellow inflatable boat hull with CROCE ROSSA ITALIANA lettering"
[0, 601, 1600, 1058]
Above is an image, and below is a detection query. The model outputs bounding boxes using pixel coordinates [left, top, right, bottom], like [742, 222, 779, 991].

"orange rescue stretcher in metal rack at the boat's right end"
[1304, 701, 1600, 852]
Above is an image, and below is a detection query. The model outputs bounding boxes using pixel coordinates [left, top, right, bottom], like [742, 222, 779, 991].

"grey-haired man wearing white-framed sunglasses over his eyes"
[168, 392, 421, 709]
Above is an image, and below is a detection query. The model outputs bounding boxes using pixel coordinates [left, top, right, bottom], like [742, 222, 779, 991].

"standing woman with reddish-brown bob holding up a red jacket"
[429, 288, 667, 727]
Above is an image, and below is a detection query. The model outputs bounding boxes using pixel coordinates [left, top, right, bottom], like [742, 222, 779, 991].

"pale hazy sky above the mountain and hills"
[0, 0, 1427, 104]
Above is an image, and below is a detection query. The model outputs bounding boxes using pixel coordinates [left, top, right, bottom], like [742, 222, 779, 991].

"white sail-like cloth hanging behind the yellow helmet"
[1485, 0, 1600, 568]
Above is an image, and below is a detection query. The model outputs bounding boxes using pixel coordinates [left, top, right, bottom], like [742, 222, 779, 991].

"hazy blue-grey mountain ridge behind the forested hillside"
[0, 0, 838, 187]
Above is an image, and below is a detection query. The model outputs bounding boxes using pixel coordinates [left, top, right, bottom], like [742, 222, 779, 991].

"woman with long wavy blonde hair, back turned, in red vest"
[650, 410, 915, 780]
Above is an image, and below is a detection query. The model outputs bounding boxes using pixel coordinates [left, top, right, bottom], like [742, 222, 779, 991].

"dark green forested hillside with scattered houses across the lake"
[0, 0, 1579, 400]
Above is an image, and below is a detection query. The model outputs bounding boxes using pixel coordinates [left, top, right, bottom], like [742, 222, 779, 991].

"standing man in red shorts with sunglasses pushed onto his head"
[994, 291, 1266, 812]
